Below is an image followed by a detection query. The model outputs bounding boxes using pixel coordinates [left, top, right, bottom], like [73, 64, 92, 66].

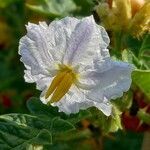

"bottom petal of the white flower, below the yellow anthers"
[49, 86, 111, 116]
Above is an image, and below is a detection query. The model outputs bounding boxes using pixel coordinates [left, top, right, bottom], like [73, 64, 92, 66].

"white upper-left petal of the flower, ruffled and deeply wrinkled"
[19, 17, 78, 75]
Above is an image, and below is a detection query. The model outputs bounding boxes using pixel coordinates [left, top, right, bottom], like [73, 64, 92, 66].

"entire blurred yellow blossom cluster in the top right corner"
[96, 0, 150, 38]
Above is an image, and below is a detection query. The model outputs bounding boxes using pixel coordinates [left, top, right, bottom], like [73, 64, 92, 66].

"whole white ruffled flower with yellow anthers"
[19, 16, 132, 116]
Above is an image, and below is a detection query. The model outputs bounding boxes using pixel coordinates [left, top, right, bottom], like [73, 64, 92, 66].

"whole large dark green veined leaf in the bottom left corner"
[0, 114, 75, 150]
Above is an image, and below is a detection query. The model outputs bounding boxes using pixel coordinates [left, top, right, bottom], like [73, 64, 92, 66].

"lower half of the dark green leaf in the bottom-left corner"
[0, 119, 51, 150]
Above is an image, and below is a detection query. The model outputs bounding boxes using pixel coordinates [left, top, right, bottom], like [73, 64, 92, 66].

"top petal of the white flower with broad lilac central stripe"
[64, 16, 109, 72]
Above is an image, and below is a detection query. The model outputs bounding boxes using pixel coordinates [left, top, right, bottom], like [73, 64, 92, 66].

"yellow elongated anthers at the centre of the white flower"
[45, 65, 78, 103]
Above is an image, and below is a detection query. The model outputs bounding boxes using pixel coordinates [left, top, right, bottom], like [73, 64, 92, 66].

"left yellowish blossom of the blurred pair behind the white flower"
[96, 0, 132, 31]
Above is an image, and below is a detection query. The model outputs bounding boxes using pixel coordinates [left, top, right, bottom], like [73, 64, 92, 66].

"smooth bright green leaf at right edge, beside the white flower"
[132, 70, 150, 100]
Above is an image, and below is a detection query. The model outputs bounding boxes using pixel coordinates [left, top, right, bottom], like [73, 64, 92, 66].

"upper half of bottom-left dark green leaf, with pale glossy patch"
[0, 114, 75, 134]
